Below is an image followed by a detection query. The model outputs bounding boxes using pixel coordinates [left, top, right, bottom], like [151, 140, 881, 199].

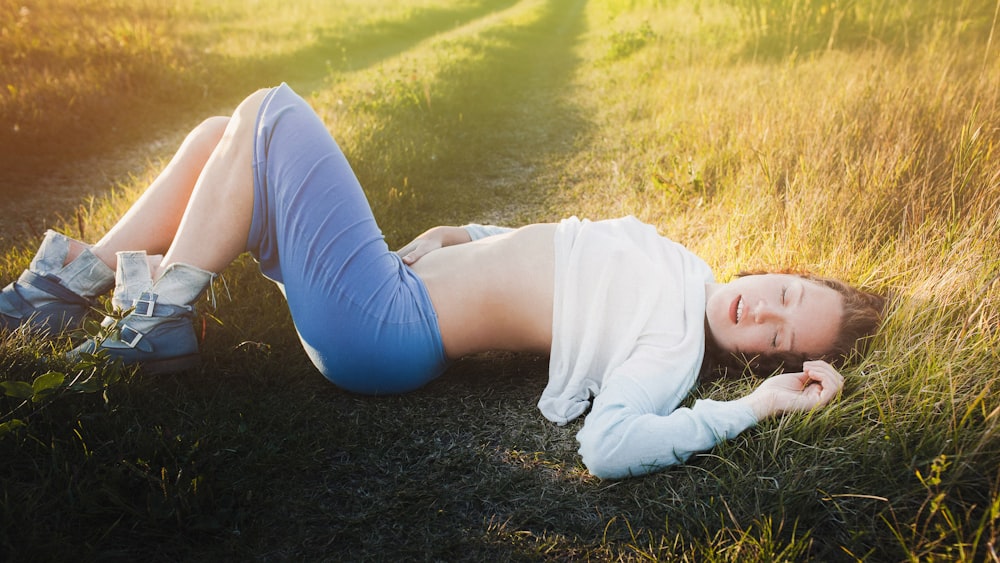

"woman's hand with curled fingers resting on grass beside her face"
[740, 360, 844, 420]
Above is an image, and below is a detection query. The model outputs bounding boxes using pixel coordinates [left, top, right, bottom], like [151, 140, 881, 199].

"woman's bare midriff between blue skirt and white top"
[412, 224, 556, 359]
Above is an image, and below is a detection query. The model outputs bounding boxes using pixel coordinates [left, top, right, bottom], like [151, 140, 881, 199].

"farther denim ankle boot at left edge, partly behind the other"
[0, 230, 115, 336]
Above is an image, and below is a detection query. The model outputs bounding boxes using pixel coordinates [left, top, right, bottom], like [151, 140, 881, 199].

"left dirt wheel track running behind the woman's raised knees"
[0, 0, 516, 249]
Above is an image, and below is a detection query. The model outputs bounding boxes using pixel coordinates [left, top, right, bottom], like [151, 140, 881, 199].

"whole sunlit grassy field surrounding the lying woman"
[0, 0, 1000, 562]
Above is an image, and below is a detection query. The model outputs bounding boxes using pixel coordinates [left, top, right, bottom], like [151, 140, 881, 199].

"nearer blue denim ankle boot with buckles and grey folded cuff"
[70, 251, 215, 373]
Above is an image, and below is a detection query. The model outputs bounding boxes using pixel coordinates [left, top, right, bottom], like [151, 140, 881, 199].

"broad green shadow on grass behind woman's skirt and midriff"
[335, 0, 588, 242]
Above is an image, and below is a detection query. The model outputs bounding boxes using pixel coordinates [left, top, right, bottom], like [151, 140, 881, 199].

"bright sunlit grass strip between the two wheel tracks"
[313, 0, 545, 240]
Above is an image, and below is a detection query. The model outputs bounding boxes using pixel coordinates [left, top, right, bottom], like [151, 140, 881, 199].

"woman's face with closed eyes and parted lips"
[705, 274, 844, 358]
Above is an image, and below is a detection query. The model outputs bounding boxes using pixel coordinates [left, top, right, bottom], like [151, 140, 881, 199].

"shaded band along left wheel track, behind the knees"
[0, 0, 515, 246]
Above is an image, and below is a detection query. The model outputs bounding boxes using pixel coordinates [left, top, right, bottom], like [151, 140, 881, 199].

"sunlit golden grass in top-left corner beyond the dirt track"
[0, 0, 500, 128]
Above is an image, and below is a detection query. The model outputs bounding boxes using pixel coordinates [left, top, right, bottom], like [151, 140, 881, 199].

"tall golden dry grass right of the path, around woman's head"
[565, 2, 1000, 560]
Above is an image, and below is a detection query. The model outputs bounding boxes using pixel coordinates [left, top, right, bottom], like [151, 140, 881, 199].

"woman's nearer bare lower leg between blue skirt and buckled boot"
[153, 90, 267, 279]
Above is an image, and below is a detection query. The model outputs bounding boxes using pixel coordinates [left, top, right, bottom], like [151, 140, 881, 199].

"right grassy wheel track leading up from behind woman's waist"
[359, 0, 589, 239]
